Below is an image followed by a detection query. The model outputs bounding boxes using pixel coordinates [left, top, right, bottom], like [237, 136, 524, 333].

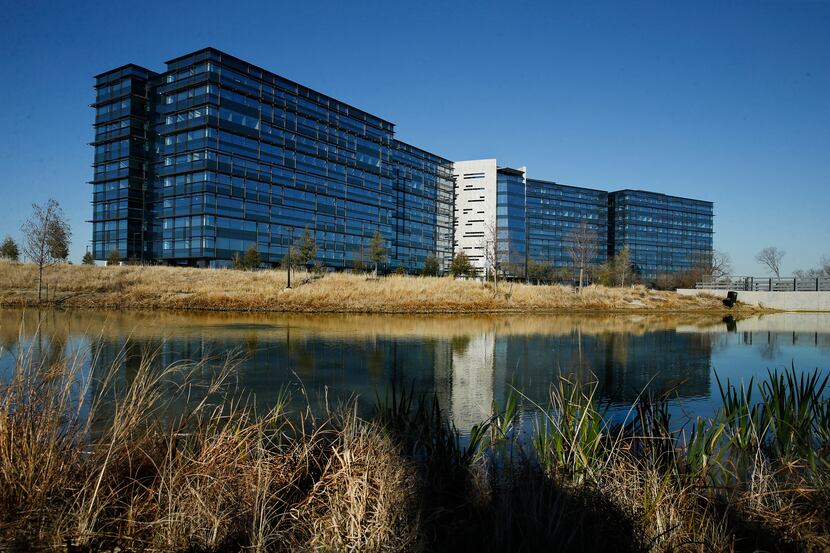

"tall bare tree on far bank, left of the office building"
[21, 198, 72, 303]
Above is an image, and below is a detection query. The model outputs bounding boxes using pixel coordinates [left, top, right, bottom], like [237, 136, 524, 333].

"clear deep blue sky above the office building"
[0, 0, 830, 275]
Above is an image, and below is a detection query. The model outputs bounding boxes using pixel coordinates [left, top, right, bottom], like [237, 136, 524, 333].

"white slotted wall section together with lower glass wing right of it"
[455, 159, 713, 282]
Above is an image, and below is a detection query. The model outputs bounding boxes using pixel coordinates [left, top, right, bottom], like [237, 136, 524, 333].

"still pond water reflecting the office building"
[0, 310, 830, 433]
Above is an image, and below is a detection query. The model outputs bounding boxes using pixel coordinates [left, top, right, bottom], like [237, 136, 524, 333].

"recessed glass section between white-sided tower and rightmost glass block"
[525, 179, 608, 269]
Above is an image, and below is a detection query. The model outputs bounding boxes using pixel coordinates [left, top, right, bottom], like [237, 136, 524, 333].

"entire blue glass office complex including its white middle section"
[91, 48, 713, 281]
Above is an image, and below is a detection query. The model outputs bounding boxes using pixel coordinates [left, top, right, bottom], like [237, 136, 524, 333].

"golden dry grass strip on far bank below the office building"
[0, 262, 747, 313]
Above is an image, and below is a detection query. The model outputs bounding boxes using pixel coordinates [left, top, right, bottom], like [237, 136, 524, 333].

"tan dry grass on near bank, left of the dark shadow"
[0, 342, 415, 551]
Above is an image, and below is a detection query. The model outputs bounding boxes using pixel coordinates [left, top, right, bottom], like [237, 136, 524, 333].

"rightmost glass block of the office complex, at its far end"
[608, 190, 713, 282]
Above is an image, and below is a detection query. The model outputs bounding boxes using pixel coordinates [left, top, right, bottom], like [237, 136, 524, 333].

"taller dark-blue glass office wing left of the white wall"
[92, 48, 453, 271]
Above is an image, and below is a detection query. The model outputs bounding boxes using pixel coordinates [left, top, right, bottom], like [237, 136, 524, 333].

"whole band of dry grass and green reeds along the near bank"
[0, 338, 830, 551]
